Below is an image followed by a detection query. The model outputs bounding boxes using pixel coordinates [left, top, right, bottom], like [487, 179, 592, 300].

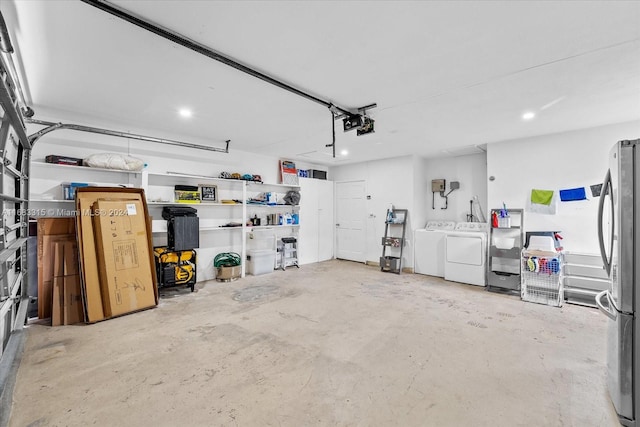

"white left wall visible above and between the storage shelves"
[29, 115, 327, 281]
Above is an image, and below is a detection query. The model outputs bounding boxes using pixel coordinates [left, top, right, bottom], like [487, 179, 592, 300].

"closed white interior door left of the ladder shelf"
[336, 181, 367, 262]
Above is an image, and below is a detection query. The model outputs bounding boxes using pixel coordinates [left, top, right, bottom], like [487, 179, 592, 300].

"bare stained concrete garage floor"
[10, 261, 619, 427]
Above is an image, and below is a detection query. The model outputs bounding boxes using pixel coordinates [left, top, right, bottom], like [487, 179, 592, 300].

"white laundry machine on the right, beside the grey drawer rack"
[444, 222, 489, 286]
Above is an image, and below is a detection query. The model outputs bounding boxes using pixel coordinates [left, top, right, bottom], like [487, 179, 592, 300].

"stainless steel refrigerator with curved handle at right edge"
[596, 139, 640, 426]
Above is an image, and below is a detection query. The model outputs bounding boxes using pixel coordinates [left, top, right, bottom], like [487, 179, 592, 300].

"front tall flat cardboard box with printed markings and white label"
[93, 199, 156, 317]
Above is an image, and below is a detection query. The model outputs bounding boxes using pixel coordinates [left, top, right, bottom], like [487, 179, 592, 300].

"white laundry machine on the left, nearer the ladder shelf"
[413, 221, 456, 277]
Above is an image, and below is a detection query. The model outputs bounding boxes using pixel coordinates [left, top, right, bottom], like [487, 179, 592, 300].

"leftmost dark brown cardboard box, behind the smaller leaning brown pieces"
[37, 218, 76, 319]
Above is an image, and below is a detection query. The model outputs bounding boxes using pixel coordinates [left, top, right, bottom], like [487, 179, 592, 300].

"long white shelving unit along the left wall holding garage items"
[29, 166, 300, 280]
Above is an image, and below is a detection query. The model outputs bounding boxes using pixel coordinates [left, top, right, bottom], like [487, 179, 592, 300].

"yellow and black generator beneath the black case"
[153, 246, 196, 292]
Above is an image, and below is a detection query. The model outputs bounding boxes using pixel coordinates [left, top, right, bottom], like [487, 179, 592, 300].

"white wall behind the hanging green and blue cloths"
[487, 121, 640, 253]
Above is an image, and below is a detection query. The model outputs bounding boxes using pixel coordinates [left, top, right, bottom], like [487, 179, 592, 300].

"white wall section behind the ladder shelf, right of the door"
[329, 156, 416, 268]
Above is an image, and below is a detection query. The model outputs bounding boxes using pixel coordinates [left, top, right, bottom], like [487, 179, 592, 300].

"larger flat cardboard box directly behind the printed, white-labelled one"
[76, 187, 158, 323]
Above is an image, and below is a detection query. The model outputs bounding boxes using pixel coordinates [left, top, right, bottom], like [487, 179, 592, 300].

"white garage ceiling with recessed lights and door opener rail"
[0, 0, 640, 164]
